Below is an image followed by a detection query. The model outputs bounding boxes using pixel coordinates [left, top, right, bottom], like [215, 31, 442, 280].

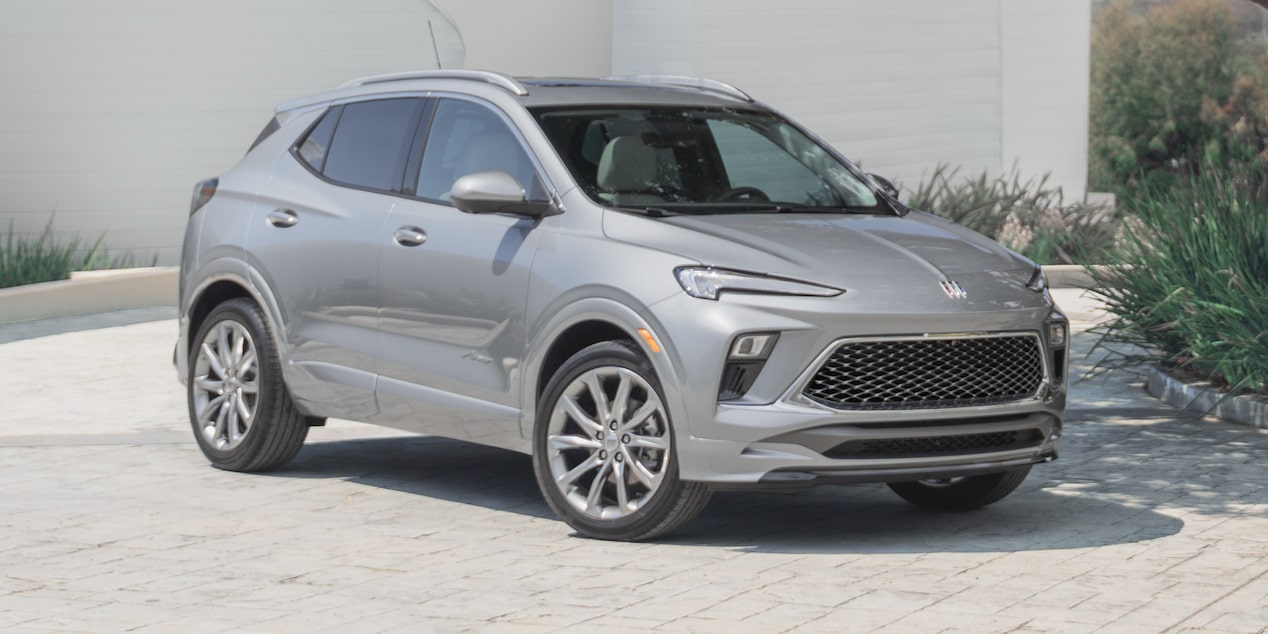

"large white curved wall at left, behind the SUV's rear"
[0, 0, 462, 264]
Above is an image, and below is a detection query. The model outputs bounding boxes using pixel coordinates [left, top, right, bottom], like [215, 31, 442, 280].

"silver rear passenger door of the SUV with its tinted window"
[247, 98, 425, 420]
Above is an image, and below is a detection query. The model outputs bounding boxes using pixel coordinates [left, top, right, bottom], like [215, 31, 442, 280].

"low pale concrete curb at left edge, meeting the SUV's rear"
[0, 266, 179, 323]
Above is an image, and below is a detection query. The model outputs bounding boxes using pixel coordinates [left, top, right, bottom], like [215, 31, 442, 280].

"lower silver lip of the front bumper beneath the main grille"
[678, 402, 1064, 488]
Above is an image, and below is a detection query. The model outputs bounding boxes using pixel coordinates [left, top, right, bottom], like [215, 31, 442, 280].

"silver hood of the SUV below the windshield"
[604, 212, 1037, 309]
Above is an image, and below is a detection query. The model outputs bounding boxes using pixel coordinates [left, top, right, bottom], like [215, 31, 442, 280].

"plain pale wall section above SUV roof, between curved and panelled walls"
[432, 0, 612, 77]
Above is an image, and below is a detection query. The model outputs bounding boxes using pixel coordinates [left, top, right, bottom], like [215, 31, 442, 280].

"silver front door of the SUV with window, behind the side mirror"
[377, 98, 541, 446]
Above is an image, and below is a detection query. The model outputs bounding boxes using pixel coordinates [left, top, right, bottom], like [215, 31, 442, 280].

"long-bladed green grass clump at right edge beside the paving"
[1092, 165, 1268, 394]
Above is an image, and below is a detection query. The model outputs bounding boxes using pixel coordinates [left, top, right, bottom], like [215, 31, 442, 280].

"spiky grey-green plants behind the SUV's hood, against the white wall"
[907, 165, 1117, 264]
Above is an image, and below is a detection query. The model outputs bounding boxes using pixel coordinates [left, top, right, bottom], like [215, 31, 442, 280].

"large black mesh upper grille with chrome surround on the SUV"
[803, 335, 1044, 410]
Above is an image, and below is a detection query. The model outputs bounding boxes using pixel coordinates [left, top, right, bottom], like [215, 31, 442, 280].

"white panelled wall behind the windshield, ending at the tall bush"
[612, 0, 1090, 198]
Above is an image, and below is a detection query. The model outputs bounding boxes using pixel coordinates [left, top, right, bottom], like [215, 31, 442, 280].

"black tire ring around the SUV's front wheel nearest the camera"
[533, 341, 682, 539]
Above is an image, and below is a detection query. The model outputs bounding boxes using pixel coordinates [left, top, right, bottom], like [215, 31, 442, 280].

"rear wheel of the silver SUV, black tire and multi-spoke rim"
[185, 298, 308, 472]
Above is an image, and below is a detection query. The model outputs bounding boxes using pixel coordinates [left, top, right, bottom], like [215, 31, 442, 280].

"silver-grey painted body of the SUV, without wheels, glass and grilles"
[178, 79, 1065, 484]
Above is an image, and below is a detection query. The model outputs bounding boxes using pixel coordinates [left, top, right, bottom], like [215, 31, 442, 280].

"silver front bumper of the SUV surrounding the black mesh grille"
[667, 291, 1068, 488]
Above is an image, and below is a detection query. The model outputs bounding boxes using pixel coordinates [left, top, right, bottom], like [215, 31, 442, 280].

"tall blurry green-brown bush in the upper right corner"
[1089, 0, 1268, 195]
